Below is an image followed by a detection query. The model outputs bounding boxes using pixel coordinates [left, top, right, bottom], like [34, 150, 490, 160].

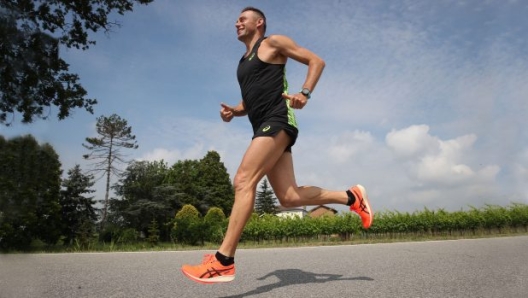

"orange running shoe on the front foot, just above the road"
[182, 255, 235, 284]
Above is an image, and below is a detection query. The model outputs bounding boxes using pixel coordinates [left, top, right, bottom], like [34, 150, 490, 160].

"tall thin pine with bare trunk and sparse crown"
[82, 114, 138, 228]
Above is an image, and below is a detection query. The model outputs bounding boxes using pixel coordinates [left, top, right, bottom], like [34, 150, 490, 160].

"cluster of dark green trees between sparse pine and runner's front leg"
[108, 151, 234, 243]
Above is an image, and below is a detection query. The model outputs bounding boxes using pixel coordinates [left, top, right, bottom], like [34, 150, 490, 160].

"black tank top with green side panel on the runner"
[237, 37, 297, 131]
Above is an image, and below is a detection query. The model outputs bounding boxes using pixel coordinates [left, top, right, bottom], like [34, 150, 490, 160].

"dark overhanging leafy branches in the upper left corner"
[0, 0, 153, 125]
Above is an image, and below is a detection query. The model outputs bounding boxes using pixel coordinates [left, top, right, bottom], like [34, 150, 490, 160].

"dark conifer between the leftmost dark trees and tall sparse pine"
[60, 164, 97, 245]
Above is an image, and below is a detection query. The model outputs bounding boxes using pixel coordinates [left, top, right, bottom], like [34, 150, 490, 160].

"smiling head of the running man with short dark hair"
[235, 6, 266, 41]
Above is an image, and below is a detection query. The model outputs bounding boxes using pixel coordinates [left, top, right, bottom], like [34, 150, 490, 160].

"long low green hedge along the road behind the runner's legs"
[242, 204, 528, 243]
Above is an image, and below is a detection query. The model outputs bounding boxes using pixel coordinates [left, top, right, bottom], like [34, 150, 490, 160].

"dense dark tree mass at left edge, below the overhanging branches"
[0, 135, 61, 249]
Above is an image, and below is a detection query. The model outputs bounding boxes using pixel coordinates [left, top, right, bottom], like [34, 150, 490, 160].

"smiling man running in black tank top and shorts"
[182, 7, 373, 283]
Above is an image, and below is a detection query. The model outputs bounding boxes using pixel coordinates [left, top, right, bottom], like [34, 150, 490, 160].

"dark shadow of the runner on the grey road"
[222, 269, 374, 298]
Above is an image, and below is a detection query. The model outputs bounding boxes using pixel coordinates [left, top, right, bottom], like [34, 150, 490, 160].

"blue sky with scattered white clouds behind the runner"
[0, 0, 528, 212]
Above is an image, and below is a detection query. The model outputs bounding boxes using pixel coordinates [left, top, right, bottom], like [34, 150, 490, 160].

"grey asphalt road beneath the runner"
[0, 236, 528, 298]
